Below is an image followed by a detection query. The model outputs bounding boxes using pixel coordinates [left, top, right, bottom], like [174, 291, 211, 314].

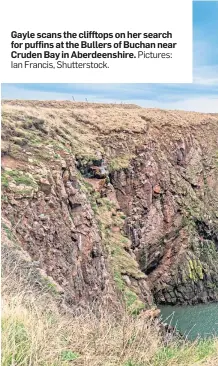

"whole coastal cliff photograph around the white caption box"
[1, 1, 218, 366]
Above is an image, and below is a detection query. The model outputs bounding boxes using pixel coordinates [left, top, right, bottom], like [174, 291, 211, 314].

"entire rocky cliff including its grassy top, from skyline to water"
[2, 101, 218, 313]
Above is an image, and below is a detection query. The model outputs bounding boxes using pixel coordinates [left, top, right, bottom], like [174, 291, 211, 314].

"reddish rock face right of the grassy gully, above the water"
[111, 119, 218, 304]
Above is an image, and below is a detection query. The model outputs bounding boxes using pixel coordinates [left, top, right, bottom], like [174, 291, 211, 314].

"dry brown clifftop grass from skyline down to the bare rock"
[2, 101, 218, 164]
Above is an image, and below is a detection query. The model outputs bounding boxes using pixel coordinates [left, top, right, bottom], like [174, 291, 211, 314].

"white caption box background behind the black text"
[1, 0, 192, 83]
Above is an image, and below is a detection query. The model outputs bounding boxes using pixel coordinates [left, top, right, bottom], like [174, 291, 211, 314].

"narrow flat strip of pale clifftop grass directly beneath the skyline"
[2, 100, 217, 132]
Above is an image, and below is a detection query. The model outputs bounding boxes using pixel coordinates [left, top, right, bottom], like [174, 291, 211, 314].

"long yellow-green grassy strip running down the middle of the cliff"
[91, 195, 145, 315]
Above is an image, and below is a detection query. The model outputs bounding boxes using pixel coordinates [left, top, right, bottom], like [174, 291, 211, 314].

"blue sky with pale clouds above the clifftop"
[2, 0, 218, 113]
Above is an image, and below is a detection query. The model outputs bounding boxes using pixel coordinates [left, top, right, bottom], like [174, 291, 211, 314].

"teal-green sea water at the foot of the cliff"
[159, 303, 218, 339]
